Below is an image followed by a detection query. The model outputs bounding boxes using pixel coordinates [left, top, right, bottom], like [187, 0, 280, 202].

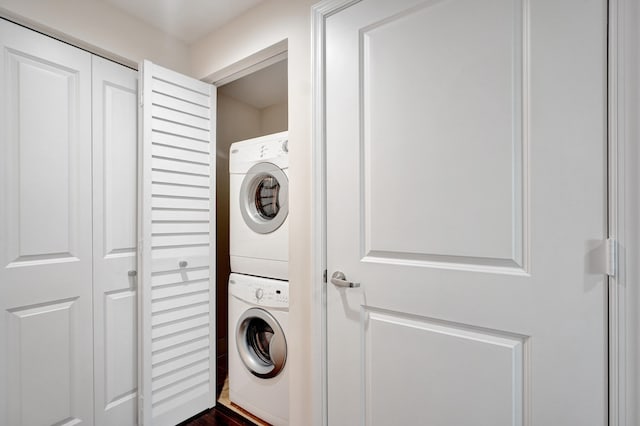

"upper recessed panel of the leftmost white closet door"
[6, 49, 82, 267]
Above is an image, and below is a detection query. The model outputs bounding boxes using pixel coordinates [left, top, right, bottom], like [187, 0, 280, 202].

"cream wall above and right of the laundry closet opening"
[191, 0, 316, 425]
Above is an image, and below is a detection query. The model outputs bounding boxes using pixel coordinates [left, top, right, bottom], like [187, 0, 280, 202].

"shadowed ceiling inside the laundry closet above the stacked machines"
[218, 60, 287, 109]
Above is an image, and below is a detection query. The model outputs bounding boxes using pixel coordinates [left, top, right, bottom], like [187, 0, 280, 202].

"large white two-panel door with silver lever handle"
[325, 0, 607, 426]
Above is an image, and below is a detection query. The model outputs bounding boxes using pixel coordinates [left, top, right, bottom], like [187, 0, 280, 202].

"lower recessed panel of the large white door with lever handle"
[362, 306, 531, 426]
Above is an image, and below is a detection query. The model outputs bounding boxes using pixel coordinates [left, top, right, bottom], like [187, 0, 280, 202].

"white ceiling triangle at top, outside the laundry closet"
[102, 0, 264, 44]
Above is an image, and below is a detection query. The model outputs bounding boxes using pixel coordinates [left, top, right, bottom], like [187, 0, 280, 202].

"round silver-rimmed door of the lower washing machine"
[236, 308, 287, 379]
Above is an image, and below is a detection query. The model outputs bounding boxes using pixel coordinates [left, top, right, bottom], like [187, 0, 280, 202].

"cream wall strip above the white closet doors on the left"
[0, 0, 190, 74]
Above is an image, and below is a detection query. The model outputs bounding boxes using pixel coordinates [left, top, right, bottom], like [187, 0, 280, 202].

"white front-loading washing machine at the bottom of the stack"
[229, 274, 289, 426]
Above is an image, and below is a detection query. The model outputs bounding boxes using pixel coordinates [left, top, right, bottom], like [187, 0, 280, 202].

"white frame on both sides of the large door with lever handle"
[311, 0, 640, 426]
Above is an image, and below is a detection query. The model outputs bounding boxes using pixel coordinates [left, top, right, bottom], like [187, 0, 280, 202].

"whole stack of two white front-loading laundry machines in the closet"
[229, 132, 289, 426]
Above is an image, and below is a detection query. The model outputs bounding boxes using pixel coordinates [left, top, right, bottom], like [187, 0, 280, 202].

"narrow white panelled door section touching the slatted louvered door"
[92, 56, 138, 426]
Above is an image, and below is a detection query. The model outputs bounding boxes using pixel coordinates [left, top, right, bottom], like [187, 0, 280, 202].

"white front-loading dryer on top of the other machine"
[229, 132, 289, 280]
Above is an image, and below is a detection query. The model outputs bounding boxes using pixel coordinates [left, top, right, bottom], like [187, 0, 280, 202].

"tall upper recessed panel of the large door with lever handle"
[360, 0, 530, 274]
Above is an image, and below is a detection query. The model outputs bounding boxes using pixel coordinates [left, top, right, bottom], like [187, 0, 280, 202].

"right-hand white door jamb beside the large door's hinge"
[608, 0, 640, 426]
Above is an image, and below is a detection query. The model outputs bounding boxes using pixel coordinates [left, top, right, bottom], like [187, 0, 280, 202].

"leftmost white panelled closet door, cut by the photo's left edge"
[0, 19, 93, 426]
